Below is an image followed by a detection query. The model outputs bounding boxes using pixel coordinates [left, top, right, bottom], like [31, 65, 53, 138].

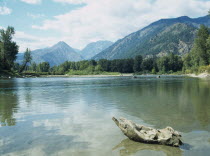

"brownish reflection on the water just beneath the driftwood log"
[112, 139, 183, 156]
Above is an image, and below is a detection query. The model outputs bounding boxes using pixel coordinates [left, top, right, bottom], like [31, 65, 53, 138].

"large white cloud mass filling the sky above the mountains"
[32, 0, 210, 48]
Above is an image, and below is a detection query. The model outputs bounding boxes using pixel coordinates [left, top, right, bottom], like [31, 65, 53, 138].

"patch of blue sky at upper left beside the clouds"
[0, 0, 83, 36]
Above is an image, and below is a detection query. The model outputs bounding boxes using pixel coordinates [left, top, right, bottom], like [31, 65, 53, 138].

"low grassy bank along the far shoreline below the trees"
[0, 65, 210, 78]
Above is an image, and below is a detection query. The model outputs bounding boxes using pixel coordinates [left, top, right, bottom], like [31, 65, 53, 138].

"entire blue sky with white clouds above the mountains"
[0, 0, 210, 52]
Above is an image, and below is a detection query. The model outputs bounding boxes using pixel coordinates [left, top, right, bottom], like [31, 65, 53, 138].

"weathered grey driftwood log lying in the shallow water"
[112, 117, 182, 147]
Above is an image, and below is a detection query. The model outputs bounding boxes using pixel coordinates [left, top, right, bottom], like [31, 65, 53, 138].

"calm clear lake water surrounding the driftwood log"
[0, 77, 210, 156]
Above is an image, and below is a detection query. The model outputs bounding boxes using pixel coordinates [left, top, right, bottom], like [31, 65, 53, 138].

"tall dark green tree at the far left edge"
[0, 26, 19, 70]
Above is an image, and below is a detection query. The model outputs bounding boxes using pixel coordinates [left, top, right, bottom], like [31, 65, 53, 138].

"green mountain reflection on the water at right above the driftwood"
[104, 79, 210, 132]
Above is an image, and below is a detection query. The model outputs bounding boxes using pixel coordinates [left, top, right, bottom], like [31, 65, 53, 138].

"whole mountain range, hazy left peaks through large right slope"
[17, 16, 210, 66]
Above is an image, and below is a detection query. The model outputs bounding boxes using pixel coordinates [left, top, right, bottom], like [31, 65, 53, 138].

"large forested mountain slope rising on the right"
[93, 16, 210, 60]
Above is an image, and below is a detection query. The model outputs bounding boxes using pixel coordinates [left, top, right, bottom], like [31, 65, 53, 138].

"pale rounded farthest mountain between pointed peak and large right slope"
[79, 41, 113, 59]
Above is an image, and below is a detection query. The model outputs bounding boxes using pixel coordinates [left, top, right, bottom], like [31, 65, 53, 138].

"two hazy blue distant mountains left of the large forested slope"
[16, 41, 113, 66]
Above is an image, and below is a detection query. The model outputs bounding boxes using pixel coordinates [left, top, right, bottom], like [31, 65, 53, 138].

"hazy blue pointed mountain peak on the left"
[17, 42, 83, 66]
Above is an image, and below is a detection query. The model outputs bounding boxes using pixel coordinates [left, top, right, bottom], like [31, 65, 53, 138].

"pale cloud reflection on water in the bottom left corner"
[0, 120, 88, 156]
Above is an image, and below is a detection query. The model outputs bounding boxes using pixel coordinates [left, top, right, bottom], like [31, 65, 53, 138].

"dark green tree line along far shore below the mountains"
[17, 53, 183, 75]
